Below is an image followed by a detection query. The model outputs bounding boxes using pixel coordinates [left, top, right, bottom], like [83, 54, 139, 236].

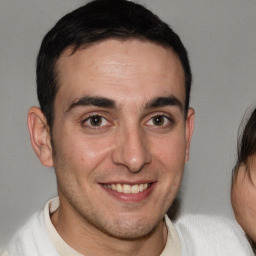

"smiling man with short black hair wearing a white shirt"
[1, 0, 254, 256]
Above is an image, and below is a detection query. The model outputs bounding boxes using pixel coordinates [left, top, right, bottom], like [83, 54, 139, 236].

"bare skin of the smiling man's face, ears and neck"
[28, 40, 194, 255]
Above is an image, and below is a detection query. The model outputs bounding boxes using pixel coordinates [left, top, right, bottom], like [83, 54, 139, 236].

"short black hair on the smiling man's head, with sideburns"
[36, 0, 192, 130]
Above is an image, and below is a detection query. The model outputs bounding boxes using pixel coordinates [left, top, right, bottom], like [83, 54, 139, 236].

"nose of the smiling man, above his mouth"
[113, 127, 152, 173]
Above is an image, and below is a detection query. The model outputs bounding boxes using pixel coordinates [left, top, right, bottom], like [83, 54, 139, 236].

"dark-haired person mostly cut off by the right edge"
[231, 108, 256, 252]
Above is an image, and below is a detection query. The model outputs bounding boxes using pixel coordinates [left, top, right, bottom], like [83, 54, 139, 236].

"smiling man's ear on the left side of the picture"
[28, 107, 53, 167]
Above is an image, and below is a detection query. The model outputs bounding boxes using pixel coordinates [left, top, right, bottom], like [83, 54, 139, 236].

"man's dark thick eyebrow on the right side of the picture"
[146, 95, 183, 110]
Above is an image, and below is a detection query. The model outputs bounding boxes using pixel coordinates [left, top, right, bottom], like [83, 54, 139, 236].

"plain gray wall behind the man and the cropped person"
[0, 0, 256, 248]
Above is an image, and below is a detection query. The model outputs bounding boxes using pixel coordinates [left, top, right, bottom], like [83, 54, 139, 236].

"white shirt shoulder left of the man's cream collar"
[4, 212, 58, 256]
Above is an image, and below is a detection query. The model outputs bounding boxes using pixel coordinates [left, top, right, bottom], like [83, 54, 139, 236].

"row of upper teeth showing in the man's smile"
[104, 183, 150, 194]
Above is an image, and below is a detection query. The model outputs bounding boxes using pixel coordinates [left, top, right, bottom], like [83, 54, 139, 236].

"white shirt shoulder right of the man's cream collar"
[175, 214, 254, 256]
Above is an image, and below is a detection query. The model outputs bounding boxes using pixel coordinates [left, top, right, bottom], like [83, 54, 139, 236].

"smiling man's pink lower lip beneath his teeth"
[100, 182, 156, 202]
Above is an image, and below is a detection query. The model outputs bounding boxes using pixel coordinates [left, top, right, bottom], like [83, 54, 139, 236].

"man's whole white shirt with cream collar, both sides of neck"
[2, 198, 254, 256]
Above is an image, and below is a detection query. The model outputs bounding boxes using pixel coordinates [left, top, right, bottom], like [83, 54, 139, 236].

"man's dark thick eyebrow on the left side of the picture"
[66, 96, 116, 112]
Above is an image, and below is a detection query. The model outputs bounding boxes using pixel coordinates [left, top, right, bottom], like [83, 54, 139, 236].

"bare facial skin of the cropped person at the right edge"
[231, 155, 256, 242]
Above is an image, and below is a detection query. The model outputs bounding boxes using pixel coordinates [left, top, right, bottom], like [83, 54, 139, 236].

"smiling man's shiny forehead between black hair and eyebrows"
[56, 39, 185, 108]
